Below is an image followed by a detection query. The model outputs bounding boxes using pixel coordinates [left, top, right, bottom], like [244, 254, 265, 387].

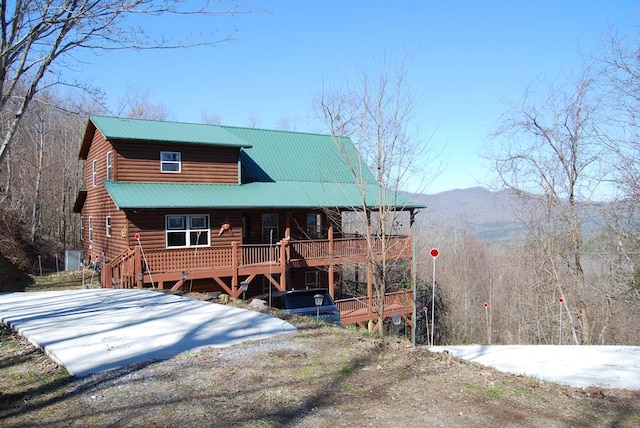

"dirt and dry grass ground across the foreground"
[0, 296, 640, 427]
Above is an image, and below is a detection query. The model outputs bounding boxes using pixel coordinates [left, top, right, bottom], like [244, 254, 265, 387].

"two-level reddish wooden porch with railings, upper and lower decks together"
[101, 236, 413, 328]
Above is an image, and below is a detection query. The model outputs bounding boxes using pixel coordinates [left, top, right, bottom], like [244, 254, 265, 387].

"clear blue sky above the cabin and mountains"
[74, 0, 640, 193]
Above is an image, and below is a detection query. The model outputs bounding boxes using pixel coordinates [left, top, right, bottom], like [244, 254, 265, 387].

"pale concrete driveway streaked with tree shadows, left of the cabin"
[0, 289, 296, 376]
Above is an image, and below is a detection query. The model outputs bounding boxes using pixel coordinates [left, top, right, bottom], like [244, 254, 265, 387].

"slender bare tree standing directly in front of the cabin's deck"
[317, 54, 428, 333]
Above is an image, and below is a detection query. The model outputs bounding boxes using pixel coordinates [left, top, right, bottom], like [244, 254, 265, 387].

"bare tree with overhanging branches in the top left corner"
[0, 0, 255, 165]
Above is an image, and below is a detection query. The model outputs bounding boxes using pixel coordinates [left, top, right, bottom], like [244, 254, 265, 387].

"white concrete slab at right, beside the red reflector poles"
[428, 345, 640, 390]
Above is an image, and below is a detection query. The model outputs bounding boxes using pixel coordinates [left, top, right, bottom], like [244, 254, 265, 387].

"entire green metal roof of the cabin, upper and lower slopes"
[80, 116, 424, 209]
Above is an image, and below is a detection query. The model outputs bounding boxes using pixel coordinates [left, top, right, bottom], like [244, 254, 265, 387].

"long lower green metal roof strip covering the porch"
[104, 180, 423, 209]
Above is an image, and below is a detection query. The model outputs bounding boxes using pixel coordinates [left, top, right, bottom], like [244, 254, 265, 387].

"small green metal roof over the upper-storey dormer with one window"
[89, 116, 251, 148]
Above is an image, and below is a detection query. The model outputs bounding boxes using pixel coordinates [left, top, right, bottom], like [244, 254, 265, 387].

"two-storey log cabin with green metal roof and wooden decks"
[74, 116, 422, 325]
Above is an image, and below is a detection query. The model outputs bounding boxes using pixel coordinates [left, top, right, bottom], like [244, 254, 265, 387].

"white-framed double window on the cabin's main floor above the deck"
[166, 215, 210, 248]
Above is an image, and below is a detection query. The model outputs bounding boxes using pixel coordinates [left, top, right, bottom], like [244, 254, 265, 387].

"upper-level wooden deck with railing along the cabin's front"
[101, 236, 411, 297]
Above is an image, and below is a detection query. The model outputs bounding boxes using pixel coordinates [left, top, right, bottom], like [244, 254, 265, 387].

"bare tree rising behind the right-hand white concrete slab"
[494, 67, 606, 344]
